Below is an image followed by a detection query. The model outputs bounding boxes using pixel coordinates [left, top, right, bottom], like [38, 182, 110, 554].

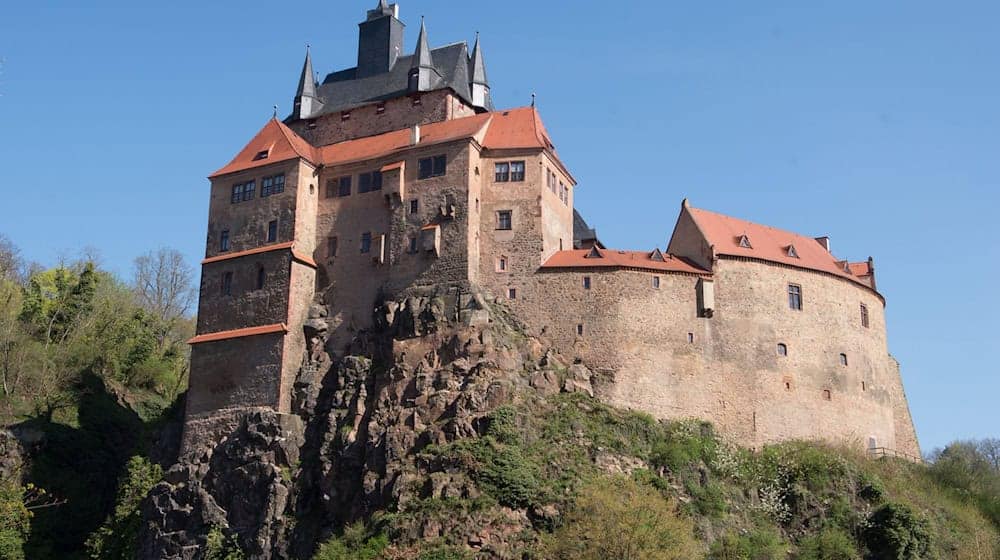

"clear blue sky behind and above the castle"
[0, 0, 1000, 450]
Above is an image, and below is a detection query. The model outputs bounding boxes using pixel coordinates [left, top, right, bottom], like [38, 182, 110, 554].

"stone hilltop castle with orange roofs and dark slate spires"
[185, 0, 920, 457]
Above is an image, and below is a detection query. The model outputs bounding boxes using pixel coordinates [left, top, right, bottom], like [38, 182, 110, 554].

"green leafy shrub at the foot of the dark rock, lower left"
[86, 456, 163, 560]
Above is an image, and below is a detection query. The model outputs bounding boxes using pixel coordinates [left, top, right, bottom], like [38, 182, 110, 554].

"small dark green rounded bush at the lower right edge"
[864, 503, 931, 560]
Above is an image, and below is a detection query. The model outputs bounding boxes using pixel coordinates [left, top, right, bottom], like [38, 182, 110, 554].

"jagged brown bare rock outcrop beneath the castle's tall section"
[142, 289, 593, 559]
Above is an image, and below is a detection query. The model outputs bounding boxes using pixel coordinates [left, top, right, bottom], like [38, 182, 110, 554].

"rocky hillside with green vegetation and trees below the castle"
[0, 245, 1000, 560]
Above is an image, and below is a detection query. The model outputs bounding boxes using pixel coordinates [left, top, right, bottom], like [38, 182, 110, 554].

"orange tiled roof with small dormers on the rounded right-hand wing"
[687, 207, 867, 285]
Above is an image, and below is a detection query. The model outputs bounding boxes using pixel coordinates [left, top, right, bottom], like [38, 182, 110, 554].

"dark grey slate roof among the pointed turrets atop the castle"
[302, 41, 472, 117]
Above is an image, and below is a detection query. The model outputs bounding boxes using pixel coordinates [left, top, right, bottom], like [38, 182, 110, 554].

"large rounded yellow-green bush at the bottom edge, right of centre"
[546, 478, 701, 560]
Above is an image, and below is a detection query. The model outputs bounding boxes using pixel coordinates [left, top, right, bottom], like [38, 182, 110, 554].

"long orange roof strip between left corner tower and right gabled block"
[319, 113, 492, 166]
